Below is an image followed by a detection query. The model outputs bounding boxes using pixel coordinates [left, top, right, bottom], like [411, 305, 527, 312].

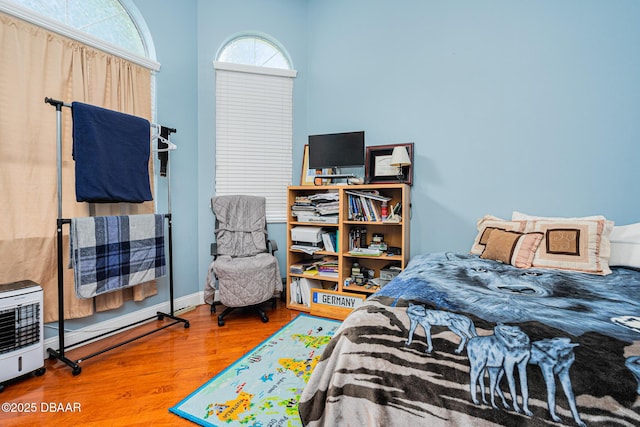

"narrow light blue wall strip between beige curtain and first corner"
[135, 0, 201, 301]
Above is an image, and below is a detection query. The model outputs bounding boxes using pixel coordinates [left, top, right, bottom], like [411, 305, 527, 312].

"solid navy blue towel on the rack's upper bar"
[72, 102, 153, 203]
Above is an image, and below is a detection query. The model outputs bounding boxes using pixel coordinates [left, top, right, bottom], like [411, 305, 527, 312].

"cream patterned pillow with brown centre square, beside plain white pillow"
[525, 218, 613, 275]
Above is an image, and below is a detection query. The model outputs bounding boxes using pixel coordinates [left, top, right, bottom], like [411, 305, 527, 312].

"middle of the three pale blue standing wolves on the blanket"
[467, 325, 533, 416]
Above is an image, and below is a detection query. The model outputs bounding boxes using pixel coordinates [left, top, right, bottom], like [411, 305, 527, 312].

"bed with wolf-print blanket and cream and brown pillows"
[299, 214, 640, 426]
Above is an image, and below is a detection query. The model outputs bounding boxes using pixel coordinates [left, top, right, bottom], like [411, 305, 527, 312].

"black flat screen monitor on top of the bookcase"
[309, 131, 364, 169]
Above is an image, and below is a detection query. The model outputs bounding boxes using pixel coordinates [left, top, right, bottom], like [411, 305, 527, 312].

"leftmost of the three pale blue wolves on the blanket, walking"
[405, 303, 478, 354]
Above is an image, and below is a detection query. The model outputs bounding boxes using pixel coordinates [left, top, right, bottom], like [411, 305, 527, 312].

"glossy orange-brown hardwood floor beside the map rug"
[0, 301, 300, 427]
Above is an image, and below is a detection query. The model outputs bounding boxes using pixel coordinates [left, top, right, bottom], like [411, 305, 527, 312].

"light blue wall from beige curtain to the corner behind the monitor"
[134, 0, 307, 308]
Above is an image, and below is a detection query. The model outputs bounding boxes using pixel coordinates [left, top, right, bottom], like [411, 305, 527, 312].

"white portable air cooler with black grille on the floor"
[0, 280, 45, 391]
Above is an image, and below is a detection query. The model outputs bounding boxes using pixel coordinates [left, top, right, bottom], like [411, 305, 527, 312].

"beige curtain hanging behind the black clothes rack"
[0, 13, 156, 322]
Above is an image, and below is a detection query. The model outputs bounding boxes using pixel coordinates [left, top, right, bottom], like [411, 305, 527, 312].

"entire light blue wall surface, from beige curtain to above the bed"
[53, 0, 640, 332]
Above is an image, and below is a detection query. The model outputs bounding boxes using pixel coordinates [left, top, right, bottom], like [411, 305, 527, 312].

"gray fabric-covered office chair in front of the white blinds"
[205, 195, 283, 326]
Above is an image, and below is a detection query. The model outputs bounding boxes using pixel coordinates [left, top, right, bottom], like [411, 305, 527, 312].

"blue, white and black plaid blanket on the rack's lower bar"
[70, 214, 166, 298]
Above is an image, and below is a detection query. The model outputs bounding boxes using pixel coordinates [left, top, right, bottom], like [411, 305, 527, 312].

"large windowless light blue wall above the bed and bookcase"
[298, 0, 640, 255]
